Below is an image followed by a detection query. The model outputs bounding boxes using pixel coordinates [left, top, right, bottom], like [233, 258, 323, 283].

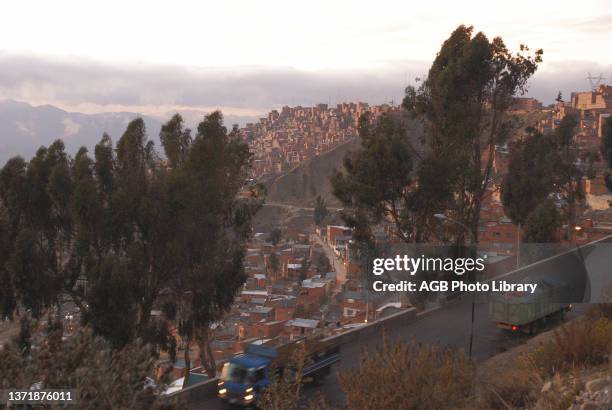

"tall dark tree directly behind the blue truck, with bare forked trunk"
[158, 111, 260, 383]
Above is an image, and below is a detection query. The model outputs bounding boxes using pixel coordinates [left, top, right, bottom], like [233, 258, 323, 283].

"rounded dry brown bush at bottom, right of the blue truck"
[338, 339, 475, 410]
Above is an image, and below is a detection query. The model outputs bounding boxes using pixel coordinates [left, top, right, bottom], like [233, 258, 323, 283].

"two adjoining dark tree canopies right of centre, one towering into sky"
[332, 25, 542, 250]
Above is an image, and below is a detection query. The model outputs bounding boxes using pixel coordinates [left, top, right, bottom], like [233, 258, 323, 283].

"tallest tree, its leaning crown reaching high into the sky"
[402, 25, 542, 245]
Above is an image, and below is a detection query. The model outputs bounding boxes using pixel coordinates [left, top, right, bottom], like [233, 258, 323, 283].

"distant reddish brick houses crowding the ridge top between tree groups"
[240, 102, 399, 178]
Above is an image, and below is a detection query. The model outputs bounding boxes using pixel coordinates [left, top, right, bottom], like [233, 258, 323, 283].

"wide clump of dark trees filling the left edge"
[0, 119, 163, 347]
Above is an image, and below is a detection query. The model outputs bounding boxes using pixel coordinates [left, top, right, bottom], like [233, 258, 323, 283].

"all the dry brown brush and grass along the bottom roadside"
[265, 312, 612, 410]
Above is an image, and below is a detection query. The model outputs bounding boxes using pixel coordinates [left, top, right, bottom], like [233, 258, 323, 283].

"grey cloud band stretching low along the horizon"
[0, 53, 612, 117]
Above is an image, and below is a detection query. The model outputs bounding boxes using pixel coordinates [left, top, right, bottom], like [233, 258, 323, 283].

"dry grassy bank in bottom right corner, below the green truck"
[475, 312, 612, 410]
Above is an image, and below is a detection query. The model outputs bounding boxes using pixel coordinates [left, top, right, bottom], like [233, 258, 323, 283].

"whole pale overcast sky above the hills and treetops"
[0, 0, 612, 121]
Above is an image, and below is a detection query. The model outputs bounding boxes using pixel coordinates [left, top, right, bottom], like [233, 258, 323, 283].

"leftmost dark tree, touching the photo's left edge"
[0, 140, 79, 317]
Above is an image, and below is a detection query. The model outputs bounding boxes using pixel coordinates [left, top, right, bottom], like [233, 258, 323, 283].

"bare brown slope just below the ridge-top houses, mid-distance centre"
[266, 138, 360, 207]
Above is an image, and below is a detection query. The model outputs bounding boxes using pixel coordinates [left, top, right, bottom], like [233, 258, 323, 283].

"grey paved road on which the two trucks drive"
[193, 237, 612, 410]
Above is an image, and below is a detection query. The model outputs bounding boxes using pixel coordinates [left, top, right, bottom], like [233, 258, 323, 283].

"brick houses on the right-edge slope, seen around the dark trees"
[479, 85, 612, 255]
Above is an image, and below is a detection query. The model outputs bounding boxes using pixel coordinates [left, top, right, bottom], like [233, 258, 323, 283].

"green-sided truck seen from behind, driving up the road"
[489, 279, 572, 334]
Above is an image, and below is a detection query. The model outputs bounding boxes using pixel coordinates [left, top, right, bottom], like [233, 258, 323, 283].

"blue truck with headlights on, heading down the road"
[217, 338, 340, 406]
